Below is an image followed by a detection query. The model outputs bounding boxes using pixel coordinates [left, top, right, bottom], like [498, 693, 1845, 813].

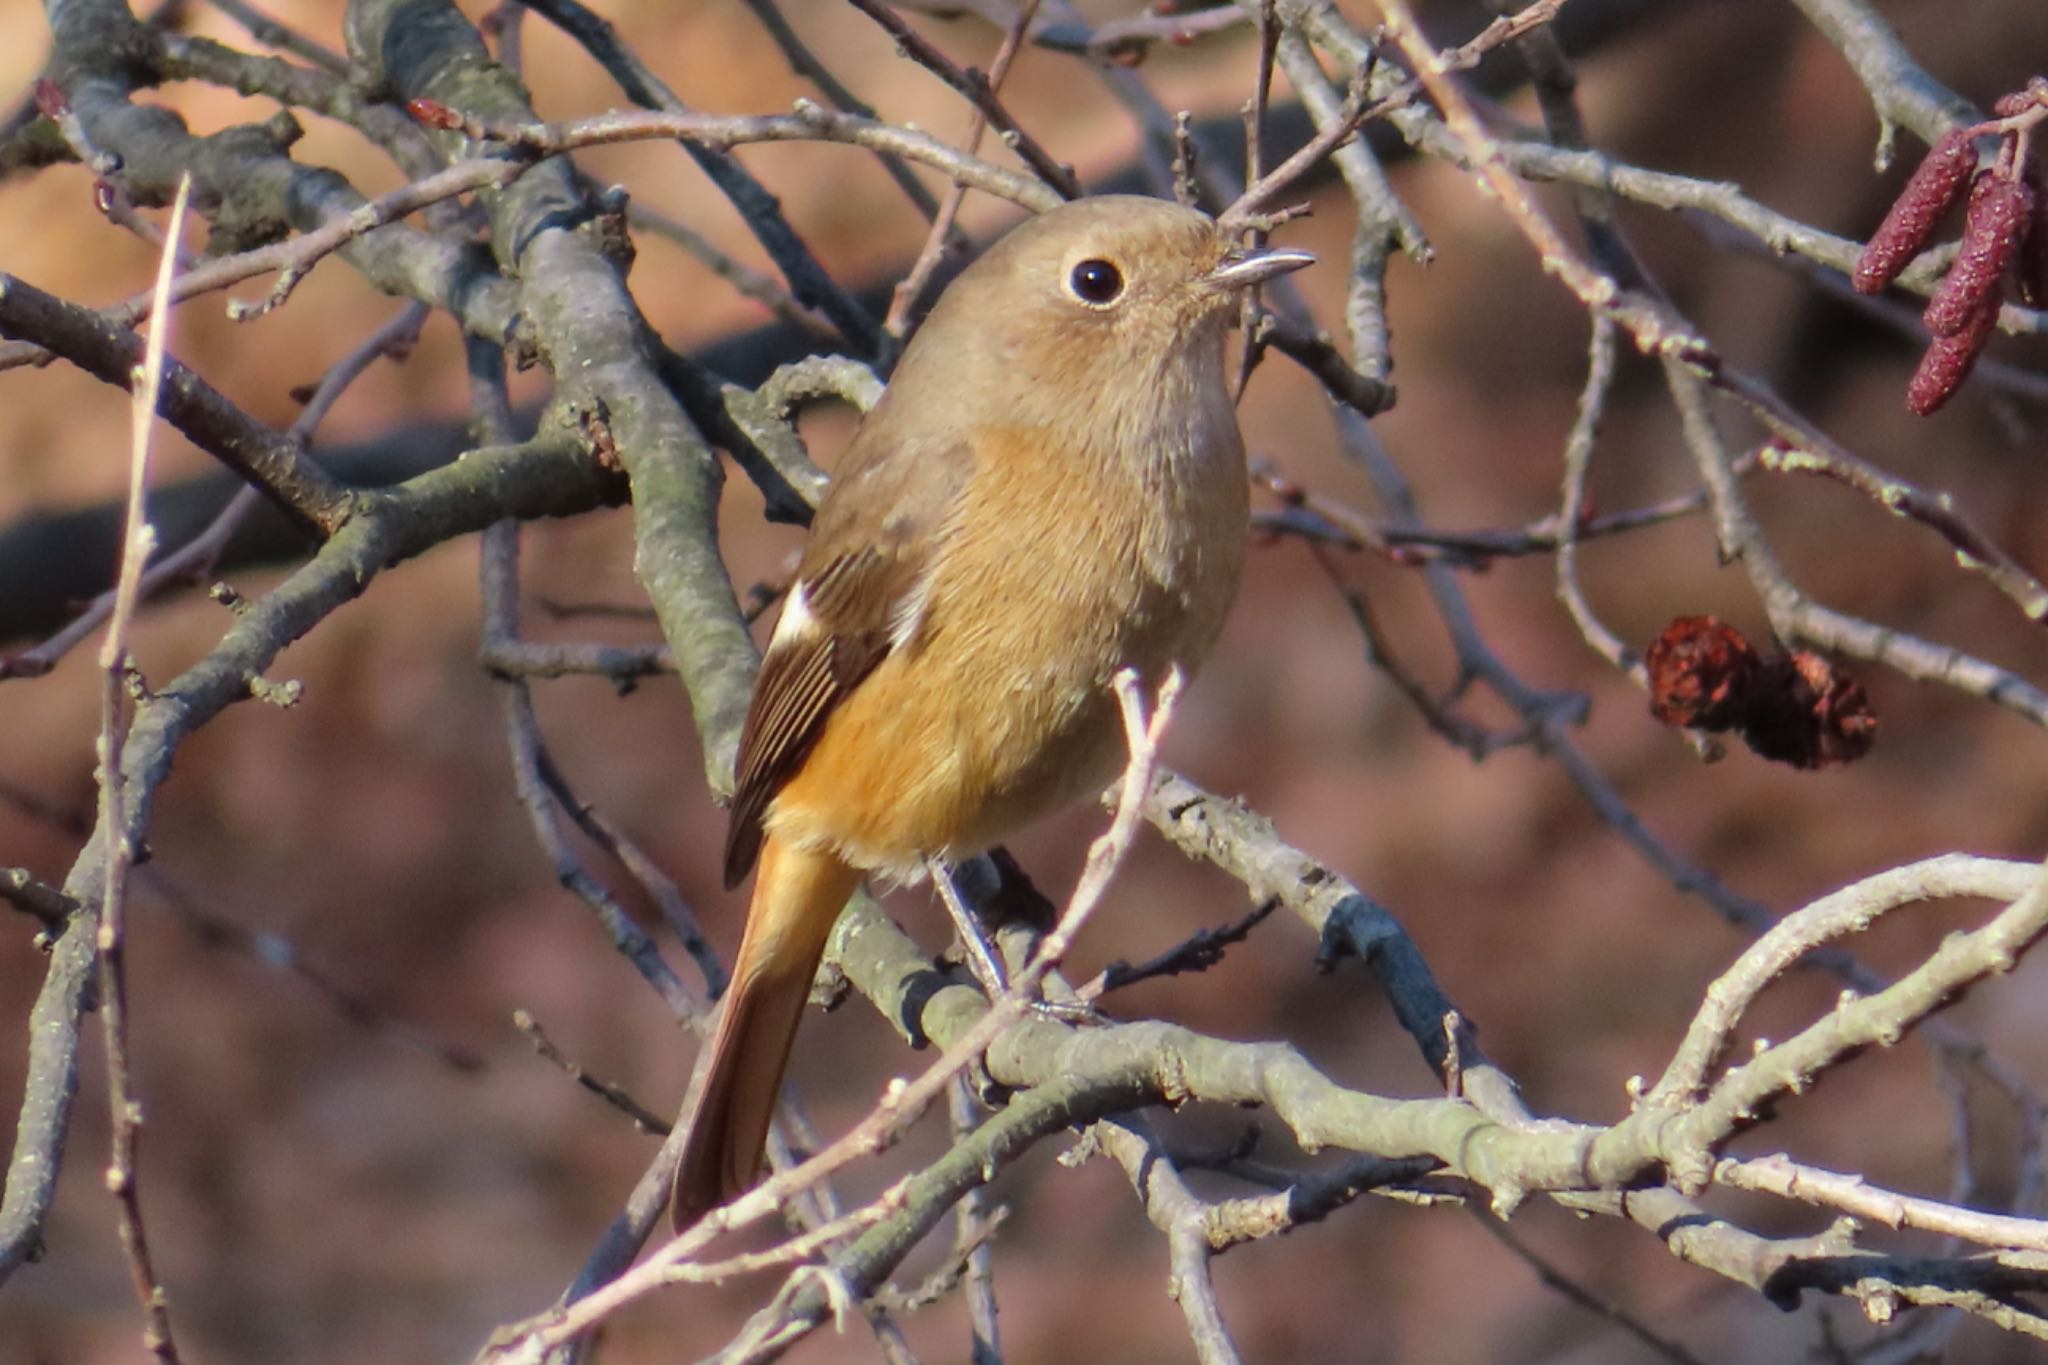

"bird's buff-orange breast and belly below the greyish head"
[768, 422, 1247, 876]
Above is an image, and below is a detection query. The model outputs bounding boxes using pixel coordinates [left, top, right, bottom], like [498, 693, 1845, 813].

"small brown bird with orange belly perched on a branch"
[674, 196, 1313, 1228]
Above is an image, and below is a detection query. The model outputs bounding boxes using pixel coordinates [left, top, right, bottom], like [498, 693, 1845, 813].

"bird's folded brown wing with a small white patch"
[725, 431, 973, 886]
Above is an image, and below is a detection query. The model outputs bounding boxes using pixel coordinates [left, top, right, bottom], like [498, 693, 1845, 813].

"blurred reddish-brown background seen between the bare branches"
[0, 0, 2048, 1365]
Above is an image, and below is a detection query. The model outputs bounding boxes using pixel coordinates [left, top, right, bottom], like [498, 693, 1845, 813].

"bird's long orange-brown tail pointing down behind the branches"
[670, 835, 860, 1232]
